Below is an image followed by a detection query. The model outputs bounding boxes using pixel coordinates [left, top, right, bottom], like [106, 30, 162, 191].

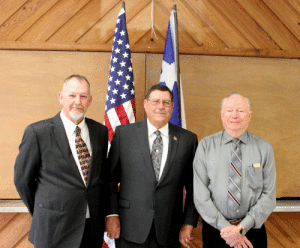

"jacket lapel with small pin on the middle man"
[159, 123, 180, 183]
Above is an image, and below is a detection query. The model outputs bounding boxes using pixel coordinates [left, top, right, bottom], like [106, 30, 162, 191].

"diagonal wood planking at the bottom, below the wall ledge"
[0, 213, 300, 248]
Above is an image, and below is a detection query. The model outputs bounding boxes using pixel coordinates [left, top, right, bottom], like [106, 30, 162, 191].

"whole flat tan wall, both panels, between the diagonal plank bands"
[0, 51, 300, 199]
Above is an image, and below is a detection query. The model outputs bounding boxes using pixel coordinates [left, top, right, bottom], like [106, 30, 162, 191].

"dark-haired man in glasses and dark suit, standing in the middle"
[107, 85, 199, 248]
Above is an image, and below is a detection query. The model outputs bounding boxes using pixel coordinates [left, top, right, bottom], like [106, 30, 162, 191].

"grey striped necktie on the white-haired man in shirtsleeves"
[228, 139, 242, 210]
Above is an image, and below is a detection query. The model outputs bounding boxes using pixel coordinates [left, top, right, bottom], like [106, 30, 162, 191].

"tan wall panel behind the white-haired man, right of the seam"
[146, 54, 300, 197]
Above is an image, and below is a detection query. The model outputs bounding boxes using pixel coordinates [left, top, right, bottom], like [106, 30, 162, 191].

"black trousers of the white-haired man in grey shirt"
[202, 220, 268, 248]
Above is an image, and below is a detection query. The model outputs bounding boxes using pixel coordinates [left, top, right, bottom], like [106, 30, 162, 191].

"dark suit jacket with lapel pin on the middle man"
[109, 120, 199, 245]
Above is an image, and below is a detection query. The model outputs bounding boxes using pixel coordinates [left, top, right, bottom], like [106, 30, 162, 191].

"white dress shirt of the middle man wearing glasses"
[147, 119, 169, 178]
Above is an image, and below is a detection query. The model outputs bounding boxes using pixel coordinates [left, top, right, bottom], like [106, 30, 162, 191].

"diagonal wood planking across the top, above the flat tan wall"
[0, 0, 300, 58]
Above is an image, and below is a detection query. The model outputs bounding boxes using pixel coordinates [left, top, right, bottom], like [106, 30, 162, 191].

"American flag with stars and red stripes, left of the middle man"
[104, 8, 136, 148]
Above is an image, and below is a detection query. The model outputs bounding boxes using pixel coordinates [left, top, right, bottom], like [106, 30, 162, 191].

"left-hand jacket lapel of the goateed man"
[53, 113, 84, 184]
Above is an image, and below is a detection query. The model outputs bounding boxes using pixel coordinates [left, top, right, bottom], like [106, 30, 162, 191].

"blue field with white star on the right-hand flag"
[160, 12, 181, 127]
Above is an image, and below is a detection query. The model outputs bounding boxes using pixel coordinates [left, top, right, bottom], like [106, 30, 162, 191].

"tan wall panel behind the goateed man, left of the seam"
[0, 51, 145, 199]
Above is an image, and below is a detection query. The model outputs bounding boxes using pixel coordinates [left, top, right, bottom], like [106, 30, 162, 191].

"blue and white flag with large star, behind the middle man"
[159, 11, 186, 128]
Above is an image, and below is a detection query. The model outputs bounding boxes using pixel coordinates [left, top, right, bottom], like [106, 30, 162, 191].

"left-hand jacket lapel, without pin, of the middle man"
[137, 119, 156, 182]
